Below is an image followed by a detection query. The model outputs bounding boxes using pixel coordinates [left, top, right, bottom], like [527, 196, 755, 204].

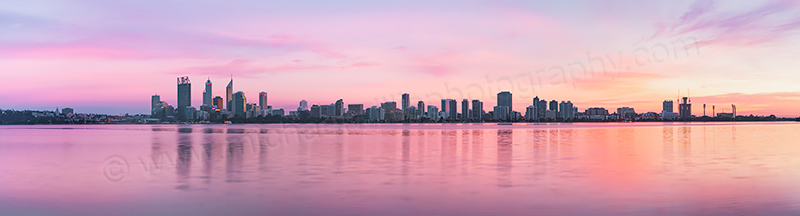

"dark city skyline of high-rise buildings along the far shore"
[151, 77, 735, 122]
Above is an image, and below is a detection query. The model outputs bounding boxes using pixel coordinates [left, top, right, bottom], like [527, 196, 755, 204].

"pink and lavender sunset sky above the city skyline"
[0, 0, 800, 117]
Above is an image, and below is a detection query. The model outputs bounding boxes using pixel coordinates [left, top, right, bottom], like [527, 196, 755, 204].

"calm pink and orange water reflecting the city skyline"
[0, 123, 800, 215]
